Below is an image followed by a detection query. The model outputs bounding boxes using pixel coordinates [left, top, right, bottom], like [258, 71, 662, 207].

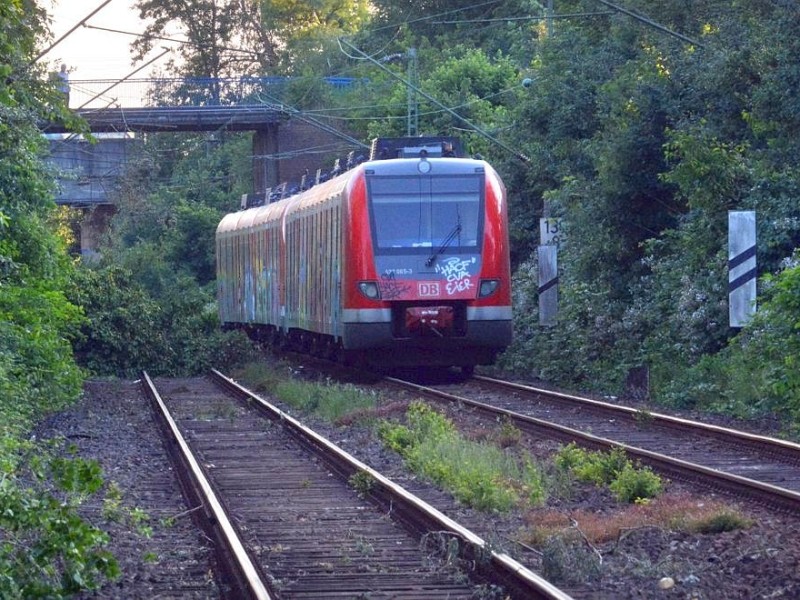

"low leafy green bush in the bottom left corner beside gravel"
[0, 436, 120, 598]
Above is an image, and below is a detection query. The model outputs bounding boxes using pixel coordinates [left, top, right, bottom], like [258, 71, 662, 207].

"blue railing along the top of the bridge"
[70, 76, 363, 108]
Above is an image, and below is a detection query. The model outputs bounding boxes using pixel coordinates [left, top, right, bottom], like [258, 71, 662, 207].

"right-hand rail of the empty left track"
[212, 370, 571, 600]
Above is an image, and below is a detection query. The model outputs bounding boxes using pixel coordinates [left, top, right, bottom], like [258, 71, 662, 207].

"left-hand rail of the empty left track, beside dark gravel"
[142, 372, 270, 600]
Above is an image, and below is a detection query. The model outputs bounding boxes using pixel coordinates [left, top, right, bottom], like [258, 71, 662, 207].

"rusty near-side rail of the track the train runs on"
[385, 377, 800, 512]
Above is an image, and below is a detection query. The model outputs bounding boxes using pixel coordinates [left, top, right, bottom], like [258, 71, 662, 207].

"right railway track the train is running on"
[387, 377, 800, 513]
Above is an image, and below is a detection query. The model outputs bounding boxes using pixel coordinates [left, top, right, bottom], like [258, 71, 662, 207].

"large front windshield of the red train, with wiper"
[368, 174, 484, 254]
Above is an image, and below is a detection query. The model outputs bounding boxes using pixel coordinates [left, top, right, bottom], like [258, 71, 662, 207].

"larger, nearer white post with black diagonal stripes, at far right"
[728, 210, 756, 327]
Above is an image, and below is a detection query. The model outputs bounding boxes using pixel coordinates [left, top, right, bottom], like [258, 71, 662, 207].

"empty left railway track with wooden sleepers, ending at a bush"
[143, 372, 569, 600]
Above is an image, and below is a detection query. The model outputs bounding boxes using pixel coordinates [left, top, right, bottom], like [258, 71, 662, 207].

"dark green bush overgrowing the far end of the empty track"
[71, 264, 252, 378]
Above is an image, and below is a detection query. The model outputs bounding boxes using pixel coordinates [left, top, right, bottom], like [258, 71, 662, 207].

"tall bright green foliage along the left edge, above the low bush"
[0, 2, 80, 432]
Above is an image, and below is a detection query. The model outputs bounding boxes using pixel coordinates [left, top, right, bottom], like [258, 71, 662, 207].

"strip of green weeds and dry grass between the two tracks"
[234, 365, 753, 582]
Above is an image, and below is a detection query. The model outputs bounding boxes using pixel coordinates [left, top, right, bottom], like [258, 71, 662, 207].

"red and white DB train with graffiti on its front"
[216, 138, 512, 373]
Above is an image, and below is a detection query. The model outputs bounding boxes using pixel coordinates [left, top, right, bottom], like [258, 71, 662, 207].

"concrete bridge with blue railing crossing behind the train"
[44, 77, 368, 255]
